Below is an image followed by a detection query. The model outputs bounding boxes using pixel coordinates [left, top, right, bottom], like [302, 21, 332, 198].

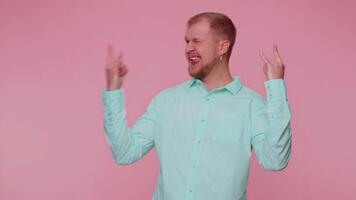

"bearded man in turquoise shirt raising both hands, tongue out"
[102, 13, 291, 200]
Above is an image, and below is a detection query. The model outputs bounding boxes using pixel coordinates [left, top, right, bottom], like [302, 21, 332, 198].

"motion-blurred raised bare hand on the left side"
[106, 45, 128, 90]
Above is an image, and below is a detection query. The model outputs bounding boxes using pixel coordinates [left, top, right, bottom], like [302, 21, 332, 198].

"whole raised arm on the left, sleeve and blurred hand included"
[102, 46, 158, 165]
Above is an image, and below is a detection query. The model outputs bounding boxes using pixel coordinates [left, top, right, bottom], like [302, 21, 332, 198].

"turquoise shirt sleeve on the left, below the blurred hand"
[102, 88, 158, 165]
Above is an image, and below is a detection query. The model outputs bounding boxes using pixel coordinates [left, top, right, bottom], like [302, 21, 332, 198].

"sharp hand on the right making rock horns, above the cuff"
[260, 44, 285, 80]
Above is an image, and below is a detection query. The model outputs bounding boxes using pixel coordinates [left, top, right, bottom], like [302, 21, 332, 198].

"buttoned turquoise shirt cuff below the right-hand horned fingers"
[265, 79, 288, 101]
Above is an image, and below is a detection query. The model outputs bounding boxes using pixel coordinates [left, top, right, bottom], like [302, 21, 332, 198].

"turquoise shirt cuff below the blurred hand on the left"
[101, 88, 125, 112]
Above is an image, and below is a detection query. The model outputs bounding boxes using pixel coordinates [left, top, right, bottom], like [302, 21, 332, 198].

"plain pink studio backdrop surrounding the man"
[0, 0, 356, 200]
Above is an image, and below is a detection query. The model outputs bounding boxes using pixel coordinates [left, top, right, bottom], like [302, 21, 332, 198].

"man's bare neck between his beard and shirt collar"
[201, 62, 234, 91]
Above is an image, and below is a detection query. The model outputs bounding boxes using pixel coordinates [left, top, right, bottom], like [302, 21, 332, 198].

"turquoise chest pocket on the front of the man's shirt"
[210, 114, 244, 143]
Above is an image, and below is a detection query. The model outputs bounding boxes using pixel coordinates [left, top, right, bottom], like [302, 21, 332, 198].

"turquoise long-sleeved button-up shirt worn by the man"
[102, 76, 291, 200]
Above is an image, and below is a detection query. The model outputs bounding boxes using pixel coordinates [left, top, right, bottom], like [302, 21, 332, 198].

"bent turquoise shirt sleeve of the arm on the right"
[251, 79, 292, 171]
